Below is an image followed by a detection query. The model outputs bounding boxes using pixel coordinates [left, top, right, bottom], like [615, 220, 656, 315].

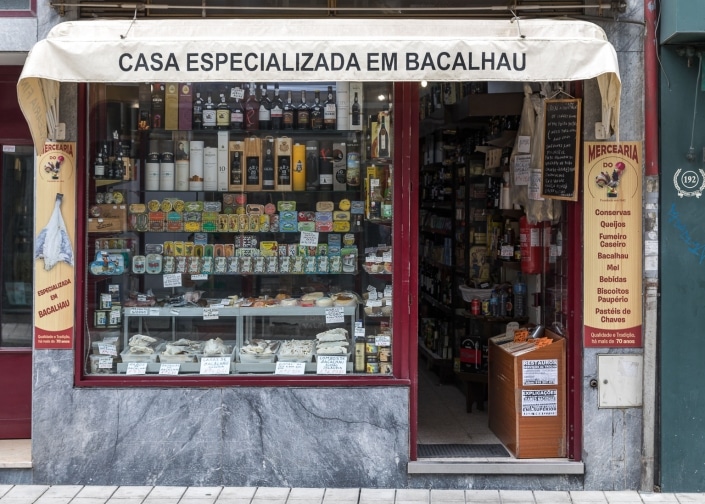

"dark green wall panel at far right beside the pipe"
[659, 46, 705, 492]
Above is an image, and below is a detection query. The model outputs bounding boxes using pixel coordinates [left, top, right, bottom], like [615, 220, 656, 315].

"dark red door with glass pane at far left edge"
[0, 66, 34, 440]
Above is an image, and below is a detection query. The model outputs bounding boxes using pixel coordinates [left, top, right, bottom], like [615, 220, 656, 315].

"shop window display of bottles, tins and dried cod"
[83, 82, 394, 376]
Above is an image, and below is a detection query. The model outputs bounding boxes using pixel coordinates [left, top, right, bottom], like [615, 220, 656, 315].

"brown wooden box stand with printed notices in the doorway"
[488, 330, 567, 458]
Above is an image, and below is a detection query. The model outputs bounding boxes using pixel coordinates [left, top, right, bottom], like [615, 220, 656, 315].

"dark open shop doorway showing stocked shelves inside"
[416, 83, 579, 459]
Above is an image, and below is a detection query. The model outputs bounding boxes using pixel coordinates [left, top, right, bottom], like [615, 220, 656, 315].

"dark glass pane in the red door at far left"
[0, 146, 34, 347]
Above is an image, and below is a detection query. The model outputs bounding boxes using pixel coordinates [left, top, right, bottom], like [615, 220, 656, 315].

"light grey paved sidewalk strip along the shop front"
[0, 485, 705, 504]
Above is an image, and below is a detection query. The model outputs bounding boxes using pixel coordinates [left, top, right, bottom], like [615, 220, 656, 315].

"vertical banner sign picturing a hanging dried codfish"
[34, 142, 76, 349]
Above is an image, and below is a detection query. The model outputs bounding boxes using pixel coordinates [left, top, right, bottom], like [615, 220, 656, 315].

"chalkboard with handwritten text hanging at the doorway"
[541, 99, 581, 201]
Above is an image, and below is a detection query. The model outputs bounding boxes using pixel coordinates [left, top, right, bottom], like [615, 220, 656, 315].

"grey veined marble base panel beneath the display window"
[32, 350, 409, 487]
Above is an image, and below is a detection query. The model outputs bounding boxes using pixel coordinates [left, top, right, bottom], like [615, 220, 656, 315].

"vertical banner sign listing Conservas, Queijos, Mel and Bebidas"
[583, 142, 643, 348]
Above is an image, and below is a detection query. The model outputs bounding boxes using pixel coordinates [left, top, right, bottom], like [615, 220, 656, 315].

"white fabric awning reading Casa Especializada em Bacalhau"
[18, 18, 621, 152]
